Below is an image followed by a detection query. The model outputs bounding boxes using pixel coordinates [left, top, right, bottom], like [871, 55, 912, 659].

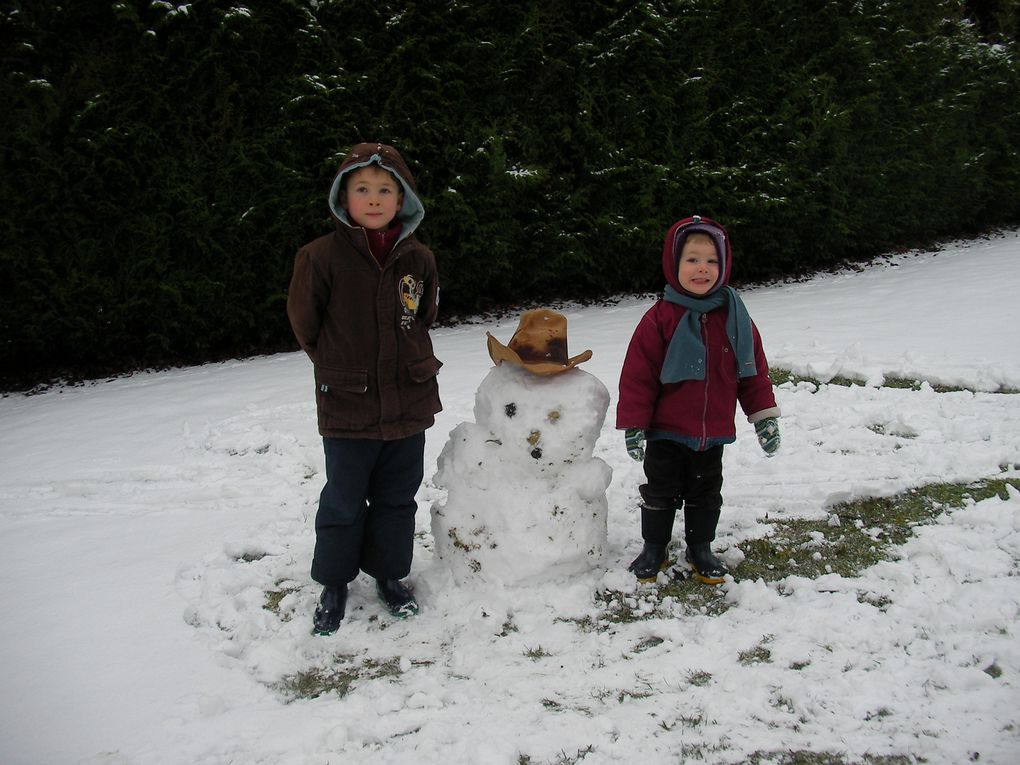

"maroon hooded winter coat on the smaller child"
[616, 218, 779, 450]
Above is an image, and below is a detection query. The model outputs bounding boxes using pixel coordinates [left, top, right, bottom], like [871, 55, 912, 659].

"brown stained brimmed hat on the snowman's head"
[486, 308, 592, 374]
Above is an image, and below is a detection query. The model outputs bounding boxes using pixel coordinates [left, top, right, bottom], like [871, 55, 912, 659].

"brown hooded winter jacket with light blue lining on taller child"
[287, 144, 443, 441]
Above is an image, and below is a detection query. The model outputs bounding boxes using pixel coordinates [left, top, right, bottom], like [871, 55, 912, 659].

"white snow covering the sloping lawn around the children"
[0, 232, 1020, 765]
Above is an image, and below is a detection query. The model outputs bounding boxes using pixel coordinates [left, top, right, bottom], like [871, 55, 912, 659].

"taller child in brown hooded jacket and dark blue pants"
[287, 144, 442, 634]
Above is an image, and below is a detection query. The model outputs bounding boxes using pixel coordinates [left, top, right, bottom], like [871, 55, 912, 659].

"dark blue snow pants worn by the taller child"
[311, 432, 425, 587]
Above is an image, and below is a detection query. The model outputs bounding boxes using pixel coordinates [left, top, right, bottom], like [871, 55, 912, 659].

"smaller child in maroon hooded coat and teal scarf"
[616, 215, 779, 584]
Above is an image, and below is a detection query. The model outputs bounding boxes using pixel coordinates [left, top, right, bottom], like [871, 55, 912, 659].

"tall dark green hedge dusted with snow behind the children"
[0, 0, 1020, 386]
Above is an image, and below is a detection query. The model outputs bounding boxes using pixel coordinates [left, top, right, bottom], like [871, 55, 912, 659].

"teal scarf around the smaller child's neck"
[659, 285, 758, 383]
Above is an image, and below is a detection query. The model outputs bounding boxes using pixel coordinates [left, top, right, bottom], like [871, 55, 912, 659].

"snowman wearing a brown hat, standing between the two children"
[431, 309, 612, 585]
